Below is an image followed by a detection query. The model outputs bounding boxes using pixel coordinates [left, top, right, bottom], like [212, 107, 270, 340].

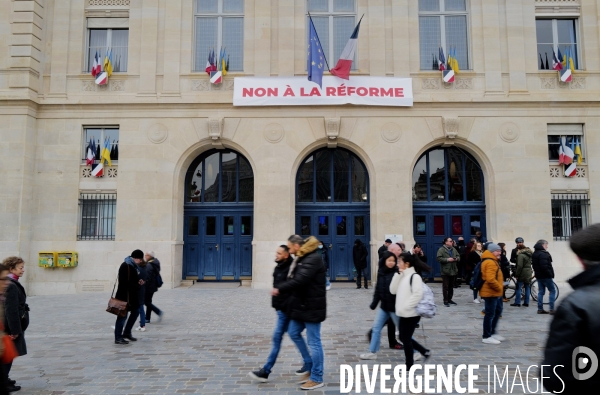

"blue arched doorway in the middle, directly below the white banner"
[296, 148, 370, 281]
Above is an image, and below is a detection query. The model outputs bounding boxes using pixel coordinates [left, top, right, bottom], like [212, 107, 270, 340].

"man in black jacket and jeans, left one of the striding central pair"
[248, 245, 311, 383]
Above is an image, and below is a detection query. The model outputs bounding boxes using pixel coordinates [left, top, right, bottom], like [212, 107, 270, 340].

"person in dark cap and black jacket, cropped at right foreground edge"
[536, 224, 600, 394]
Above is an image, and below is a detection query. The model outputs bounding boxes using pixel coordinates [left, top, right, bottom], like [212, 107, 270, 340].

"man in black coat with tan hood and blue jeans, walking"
[271, 235, 327, 390]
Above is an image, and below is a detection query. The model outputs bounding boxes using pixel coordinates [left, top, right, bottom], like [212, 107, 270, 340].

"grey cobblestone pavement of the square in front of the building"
[11, 283, 567, 395]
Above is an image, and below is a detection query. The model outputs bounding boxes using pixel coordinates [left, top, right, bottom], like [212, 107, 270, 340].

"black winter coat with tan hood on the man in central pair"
[276, 236, 327, 323]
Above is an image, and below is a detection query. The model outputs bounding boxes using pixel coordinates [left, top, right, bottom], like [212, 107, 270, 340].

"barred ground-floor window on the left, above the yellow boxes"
[77, 193, 117, 240]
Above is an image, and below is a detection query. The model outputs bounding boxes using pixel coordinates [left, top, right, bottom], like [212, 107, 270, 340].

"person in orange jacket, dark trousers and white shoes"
[479, 243, 504, 344]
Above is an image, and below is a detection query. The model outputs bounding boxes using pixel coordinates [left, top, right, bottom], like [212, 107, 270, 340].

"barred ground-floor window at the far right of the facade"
[552, 193, 590, 240]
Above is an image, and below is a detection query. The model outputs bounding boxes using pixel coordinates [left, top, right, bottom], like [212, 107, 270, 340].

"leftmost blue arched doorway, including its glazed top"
[183, 150, 254, 281]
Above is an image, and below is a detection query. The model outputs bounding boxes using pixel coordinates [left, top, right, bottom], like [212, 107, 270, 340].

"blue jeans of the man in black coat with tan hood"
[288, 320, 323, 383]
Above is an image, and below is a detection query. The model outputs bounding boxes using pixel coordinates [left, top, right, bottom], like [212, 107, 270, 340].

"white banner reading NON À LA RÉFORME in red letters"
[233, 76, 413, 106]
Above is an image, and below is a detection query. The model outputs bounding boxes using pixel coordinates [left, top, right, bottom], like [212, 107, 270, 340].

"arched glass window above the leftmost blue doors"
[185, 150, 254, 203]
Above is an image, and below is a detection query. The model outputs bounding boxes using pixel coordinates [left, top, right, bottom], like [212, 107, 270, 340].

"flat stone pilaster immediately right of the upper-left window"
[138, 0, 159, 96]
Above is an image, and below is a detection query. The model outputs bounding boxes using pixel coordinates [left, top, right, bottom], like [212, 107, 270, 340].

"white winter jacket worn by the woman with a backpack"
[390, 267, 423, 317]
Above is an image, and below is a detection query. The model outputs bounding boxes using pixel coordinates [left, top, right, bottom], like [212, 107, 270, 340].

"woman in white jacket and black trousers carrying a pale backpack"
[390, 252, 431, 371]
